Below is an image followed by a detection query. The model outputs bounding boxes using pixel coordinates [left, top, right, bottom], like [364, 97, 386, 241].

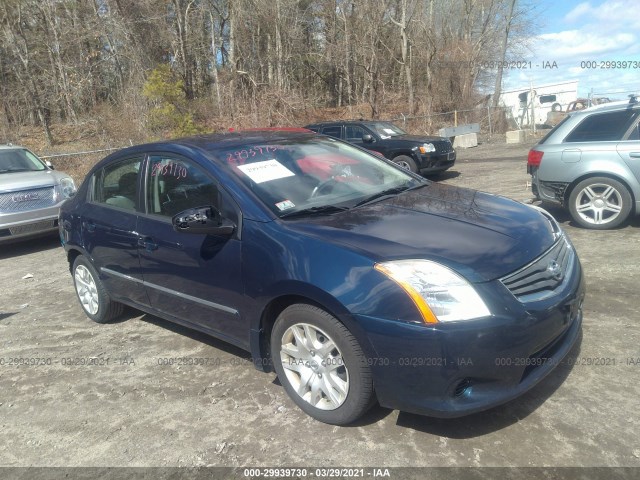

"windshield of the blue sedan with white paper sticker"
[222, 137, 427, 217]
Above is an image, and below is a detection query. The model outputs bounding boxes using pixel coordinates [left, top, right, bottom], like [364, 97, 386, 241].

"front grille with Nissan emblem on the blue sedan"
[500, 235, 575, 302]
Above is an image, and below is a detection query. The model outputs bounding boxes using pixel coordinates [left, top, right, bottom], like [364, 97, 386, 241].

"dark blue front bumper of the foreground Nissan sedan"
[357, 256, 585, 418]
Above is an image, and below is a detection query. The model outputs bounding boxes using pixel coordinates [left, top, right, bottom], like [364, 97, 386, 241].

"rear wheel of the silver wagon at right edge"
[569, 177, 632, 230]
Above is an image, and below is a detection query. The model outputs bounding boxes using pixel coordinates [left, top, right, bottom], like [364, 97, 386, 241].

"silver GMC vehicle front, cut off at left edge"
[0, 145, 76, 243]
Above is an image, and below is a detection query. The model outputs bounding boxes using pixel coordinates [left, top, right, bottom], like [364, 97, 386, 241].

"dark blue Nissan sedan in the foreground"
[60, 130, 585, 424]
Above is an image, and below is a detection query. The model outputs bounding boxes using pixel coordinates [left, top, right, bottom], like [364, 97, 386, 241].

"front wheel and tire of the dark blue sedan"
[271, 304, 374, 425]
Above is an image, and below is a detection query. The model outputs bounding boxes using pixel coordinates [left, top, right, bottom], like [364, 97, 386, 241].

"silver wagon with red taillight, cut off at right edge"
[527, 97, 640, 230]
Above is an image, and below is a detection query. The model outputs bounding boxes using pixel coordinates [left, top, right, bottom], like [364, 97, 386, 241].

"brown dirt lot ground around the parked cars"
[0, 143, 640, 478]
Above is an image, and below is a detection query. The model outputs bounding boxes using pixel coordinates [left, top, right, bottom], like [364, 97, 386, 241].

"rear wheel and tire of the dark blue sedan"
[71, 255, 124, 323]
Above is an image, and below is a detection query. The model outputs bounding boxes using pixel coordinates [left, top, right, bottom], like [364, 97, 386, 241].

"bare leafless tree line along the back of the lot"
[0, 0, 531, 140]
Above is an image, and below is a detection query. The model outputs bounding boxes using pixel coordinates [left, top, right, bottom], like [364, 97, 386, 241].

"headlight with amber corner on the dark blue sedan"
[375, 260, 491, 323]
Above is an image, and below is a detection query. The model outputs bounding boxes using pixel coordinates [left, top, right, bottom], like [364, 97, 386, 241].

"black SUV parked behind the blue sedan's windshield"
[305, 120, 456, 175]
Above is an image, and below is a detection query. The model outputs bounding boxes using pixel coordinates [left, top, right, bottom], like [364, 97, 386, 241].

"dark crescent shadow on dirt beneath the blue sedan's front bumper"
[396, 332, 582, 439]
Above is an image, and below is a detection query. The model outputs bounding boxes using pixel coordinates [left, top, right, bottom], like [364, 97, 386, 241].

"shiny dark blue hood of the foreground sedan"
[287, 183, 558, 282]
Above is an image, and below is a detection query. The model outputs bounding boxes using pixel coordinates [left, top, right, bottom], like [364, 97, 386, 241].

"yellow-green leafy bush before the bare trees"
[142, 65, 203, 137]
